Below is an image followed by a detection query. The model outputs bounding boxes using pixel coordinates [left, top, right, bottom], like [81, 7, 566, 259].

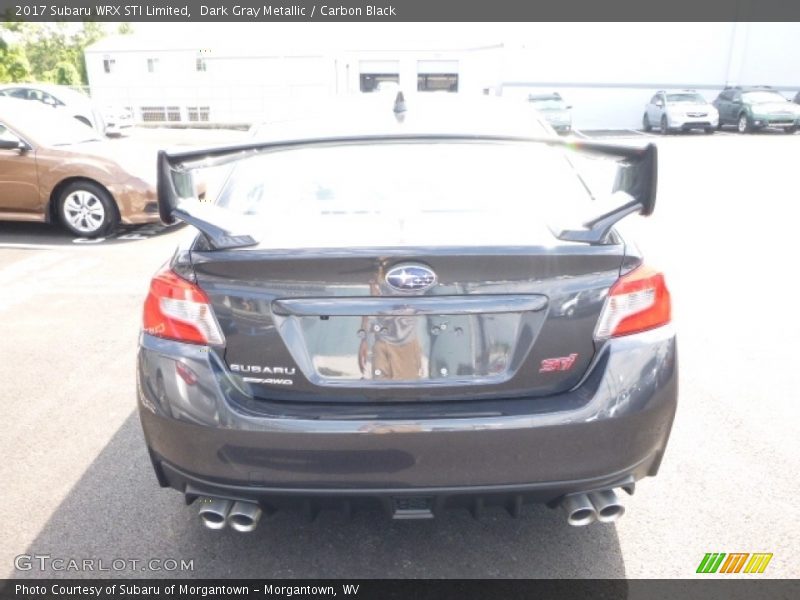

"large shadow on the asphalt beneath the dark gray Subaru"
[12, 413, 625, 578]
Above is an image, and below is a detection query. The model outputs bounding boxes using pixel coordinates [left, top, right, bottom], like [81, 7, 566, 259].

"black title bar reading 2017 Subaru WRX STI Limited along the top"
[0, 0, 800, 22]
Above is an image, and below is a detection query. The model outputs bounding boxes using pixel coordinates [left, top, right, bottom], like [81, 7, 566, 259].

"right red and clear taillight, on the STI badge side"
[594, 265, 672, 340]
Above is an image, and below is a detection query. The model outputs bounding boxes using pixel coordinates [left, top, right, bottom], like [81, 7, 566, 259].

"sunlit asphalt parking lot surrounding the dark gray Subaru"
[0, 131, 800, 578]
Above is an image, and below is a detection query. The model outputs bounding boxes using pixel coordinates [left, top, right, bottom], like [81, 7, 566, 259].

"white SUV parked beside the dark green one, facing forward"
[642, 90, 719, 134]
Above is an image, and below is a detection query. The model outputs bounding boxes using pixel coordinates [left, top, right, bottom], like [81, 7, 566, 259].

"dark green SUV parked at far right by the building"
[714, 86, 800, 133]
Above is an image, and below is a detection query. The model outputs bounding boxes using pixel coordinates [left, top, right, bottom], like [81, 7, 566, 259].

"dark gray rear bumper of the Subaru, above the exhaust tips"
[138, 327, 678, 506]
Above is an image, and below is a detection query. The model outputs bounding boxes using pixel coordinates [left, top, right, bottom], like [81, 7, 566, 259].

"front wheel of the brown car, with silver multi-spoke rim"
[58, 181, 118, 238]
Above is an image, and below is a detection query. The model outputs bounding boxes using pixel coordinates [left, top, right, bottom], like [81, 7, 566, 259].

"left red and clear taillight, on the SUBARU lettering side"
[142, 268, 225, 345]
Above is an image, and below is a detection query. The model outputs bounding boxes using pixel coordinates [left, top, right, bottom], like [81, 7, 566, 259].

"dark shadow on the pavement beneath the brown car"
[0, 222, 183, 247]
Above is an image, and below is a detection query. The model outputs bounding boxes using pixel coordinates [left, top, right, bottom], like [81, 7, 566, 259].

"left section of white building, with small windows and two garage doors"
[85, 36, 503, 123]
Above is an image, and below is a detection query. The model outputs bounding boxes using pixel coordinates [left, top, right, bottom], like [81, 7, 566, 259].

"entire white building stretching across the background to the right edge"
[86, 23, 800, 129]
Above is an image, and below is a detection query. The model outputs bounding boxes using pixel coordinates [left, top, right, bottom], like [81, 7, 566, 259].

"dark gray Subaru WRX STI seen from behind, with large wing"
[138, 97, 677, 531]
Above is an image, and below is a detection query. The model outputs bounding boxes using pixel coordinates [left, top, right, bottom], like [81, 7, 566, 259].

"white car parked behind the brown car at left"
[0, 83, 133, 135]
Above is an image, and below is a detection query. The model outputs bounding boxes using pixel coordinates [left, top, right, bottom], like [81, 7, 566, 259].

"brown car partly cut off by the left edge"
[0, 98, 158, 237]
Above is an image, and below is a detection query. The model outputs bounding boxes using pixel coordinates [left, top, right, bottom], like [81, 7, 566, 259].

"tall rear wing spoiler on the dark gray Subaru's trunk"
[157, 135, 658, 249]
